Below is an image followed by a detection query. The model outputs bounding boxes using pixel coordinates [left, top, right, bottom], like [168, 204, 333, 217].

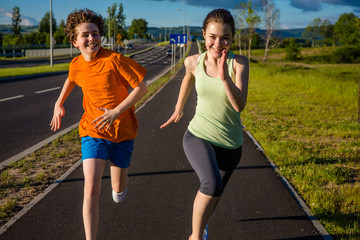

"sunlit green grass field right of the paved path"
[238, 48, 360, 239]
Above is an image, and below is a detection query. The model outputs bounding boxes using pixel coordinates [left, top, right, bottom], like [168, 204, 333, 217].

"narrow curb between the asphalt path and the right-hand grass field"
[245, 131, 333, 240]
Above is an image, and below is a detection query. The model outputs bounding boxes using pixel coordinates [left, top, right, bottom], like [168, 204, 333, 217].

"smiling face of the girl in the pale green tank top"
[203, 22, 232, 58]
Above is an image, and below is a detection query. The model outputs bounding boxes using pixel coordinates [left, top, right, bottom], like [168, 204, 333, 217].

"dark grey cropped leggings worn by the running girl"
[183, 130, 242, 197]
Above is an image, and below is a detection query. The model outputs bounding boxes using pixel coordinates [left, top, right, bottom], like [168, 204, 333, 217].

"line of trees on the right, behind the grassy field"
[233, 0, 360, 61]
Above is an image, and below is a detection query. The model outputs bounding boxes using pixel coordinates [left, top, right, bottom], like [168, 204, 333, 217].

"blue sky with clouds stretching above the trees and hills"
[0, 0, 360, 29]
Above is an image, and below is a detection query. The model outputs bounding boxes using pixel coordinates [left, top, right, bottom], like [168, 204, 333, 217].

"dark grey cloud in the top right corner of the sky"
[290, 0, 360, 12]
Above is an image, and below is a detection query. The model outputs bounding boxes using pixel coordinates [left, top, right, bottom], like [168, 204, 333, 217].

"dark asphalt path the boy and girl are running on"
[0, 43, 322, 240]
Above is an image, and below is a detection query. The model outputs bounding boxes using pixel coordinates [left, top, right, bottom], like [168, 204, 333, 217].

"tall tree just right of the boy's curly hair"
[105, 3, 126, 39]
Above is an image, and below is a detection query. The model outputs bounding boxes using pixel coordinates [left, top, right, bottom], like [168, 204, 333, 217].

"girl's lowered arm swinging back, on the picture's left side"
[160, 55, 198, 129]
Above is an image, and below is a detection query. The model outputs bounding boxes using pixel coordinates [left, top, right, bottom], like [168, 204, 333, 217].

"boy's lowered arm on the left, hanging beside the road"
[50, 78, 76, 132]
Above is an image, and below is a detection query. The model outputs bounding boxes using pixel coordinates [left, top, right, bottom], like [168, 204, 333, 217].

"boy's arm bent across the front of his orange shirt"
[93, 81, 147, 130]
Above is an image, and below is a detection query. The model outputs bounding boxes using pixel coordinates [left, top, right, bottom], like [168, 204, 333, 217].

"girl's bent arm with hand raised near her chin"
[219, 51, 249, 112]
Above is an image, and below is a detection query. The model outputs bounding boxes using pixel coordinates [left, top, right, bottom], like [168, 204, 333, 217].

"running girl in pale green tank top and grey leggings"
[160, 9, 249, 240]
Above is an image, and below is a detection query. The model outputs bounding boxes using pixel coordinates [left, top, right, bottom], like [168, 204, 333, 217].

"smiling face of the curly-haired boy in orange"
[73, 23, 101, 61]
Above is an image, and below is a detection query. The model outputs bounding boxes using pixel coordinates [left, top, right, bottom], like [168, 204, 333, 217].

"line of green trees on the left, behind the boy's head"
[0, 3, 149, 46]
